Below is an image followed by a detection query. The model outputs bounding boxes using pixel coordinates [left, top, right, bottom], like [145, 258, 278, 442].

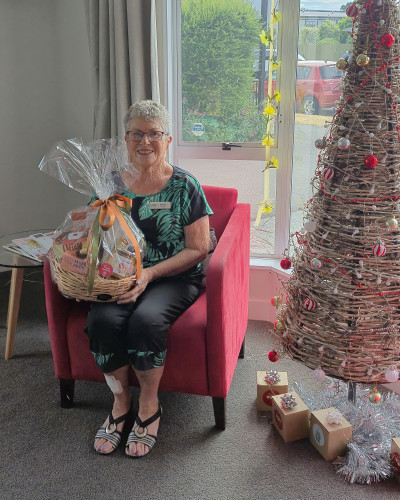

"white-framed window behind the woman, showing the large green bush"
[169, 0, 303, 257]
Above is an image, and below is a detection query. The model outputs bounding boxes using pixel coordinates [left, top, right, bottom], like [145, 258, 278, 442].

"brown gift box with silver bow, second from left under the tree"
[272, 391, 310, 443]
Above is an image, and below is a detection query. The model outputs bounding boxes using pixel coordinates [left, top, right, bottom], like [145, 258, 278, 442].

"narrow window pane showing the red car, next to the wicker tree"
[290, 0, 352, 240]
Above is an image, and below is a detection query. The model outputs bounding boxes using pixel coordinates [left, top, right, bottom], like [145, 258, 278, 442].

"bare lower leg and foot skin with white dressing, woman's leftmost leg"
[94, 365, 131, 453]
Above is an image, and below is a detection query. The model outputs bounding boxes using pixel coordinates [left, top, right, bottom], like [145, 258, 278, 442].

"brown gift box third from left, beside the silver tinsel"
[310, 407, 352, 460]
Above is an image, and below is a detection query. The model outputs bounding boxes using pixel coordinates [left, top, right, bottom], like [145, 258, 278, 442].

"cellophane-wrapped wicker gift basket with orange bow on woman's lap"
[39, 138, 145, 302]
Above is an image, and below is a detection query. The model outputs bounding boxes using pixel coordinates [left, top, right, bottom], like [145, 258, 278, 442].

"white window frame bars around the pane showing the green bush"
[165, 0, 300, 265]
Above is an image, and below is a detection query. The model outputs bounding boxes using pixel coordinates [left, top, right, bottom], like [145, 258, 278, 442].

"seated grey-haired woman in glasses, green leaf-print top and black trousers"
[86, 101, 212, 458]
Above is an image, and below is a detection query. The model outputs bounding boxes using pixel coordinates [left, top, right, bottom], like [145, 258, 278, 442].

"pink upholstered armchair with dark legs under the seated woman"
[44, 186, 250, 429]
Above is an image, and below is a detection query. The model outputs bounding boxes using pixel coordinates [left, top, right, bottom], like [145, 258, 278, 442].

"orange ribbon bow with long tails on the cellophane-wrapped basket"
[88, 194, 141, 293]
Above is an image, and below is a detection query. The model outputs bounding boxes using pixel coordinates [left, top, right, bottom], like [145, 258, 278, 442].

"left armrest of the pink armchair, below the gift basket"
[43, 259, 73, 378]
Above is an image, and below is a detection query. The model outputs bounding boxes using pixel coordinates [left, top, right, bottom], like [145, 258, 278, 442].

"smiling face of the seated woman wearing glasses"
[125, 118, 172, 168]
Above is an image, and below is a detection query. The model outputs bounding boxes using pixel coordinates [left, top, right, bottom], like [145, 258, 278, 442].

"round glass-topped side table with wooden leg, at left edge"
[0, 229, 50, 359]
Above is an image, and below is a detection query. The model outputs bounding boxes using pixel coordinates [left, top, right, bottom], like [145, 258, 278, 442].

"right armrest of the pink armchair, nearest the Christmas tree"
[206, 203, 250, 397]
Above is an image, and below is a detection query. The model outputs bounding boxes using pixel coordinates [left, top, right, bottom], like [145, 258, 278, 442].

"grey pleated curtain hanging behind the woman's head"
[85, 0, 160, 139]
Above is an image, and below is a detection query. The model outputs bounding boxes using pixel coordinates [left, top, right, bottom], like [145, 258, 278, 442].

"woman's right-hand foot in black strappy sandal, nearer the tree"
[126, 401, 162, 458]
